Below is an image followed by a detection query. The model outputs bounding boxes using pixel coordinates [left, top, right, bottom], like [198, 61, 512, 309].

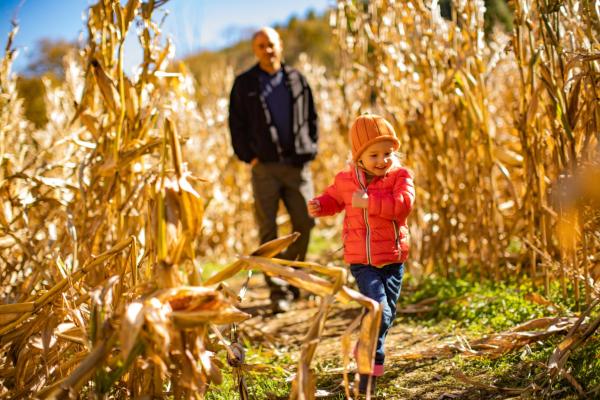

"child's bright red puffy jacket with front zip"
[316, 165, 415, 267]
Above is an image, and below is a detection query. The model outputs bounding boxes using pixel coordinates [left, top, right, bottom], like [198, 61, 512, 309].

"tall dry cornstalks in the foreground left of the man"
[0, 0, 247, 398]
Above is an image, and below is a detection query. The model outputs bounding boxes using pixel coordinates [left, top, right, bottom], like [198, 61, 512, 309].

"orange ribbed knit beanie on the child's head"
[350, 114, 400, 162]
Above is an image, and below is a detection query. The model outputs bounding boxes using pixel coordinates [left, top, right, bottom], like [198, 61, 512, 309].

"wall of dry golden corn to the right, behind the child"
[332, 0, 600, 304]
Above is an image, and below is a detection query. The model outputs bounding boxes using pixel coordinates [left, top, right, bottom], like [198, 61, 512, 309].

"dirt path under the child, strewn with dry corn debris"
[232, 276, 511, 400]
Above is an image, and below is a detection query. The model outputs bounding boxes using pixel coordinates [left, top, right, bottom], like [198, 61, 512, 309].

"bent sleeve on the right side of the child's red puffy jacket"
[369, 168, 415, 220]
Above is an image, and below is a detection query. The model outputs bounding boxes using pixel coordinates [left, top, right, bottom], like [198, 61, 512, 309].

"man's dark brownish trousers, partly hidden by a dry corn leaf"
[252, 162, 315, 300]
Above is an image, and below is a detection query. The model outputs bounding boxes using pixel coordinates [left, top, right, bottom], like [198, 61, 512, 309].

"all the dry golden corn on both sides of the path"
[0, 0, 600, 398]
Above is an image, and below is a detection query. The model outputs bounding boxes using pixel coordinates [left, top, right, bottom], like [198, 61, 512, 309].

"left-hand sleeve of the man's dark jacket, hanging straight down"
[229, 77, 255, 163]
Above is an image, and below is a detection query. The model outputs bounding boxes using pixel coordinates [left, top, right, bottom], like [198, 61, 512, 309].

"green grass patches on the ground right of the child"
[400, 277, 600, 399]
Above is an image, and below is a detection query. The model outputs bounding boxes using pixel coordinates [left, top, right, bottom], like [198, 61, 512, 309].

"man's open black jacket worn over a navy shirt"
[229, 64, 319, 166]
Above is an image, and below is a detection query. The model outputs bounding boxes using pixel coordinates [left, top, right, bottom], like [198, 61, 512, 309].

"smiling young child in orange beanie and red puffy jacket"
[308, 114, 415, 393]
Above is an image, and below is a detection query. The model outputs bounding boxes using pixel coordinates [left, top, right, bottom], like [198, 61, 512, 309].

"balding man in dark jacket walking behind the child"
[229, 27, 318, 312]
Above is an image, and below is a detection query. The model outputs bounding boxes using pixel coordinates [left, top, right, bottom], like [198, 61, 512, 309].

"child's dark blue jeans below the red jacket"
[350, 263, 404, 365]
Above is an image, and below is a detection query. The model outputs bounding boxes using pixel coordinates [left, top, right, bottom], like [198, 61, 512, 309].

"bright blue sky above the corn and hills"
[0, 0, 335, 72]
